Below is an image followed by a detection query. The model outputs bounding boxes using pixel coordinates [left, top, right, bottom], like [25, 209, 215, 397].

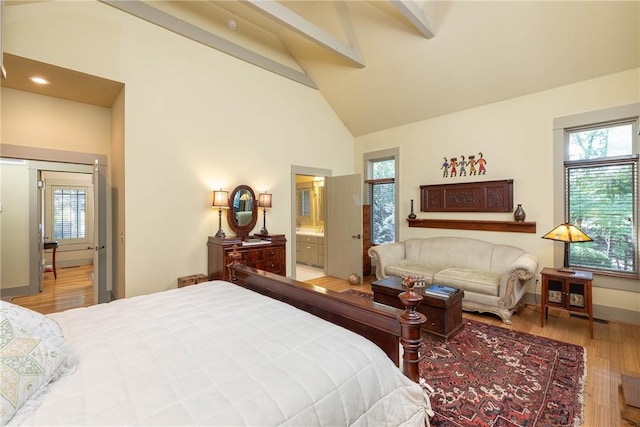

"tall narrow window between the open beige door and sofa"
[365, 150, 398, 245]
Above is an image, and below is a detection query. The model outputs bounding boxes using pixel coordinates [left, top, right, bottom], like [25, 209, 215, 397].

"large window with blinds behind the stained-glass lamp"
[564, 119, 639, 277]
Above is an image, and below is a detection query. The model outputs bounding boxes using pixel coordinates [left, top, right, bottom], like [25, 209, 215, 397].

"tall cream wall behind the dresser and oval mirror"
[3, 2, 354, 296]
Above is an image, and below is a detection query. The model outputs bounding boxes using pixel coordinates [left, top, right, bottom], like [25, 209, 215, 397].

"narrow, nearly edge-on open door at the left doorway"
[93, 160, 111, 304]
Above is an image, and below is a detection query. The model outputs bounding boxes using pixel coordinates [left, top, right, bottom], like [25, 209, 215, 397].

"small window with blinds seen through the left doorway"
[52, 186, 87, 243]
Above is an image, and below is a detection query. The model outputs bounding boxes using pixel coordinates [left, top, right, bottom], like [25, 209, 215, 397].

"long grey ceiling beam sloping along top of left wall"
[99, 0, 318, 89]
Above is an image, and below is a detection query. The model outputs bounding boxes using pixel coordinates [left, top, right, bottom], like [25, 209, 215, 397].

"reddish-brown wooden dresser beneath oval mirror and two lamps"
[207, 234, 287, 280]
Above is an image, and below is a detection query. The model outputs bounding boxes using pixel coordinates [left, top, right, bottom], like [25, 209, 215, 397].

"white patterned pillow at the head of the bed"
[0, 301, 77, 425]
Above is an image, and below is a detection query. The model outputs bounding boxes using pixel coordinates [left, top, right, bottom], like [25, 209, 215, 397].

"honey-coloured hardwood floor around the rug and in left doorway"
[8, 266, 640, 427]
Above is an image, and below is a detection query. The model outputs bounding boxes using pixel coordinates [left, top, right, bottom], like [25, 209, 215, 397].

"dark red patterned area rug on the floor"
[420, 319, 586, 427]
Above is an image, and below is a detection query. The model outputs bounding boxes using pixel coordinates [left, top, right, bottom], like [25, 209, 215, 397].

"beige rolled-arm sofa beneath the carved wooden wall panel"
[369, 237, 538, 323]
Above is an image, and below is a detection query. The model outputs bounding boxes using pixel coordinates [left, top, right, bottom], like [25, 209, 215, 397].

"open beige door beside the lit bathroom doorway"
[325, 174, 362, 279]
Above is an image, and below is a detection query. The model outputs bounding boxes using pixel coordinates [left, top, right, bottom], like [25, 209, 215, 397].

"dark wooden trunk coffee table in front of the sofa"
[371, 276, 464, 340]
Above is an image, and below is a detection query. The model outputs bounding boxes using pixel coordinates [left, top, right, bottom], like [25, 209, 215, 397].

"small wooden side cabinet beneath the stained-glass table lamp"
[540, 268, 593, 338]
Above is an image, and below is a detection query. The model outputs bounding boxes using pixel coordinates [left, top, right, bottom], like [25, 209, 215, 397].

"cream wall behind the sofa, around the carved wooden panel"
[356, 69, 640, 323]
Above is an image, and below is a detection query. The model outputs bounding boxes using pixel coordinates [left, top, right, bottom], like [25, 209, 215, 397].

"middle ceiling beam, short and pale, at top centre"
[242, 0, 365, 68]
